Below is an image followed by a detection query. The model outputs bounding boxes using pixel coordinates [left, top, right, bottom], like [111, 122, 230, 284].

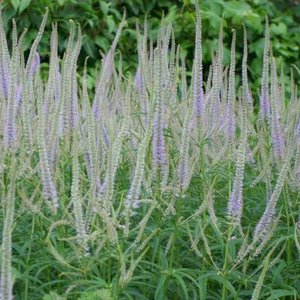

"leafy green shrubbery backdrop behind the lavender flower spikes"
[2, 0, 300, 86]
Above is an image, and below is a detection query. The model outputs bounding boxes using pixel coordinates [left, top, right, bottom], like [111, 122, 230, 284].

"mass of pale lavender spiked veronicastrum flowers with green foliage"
[0, 5, 300, 300]
